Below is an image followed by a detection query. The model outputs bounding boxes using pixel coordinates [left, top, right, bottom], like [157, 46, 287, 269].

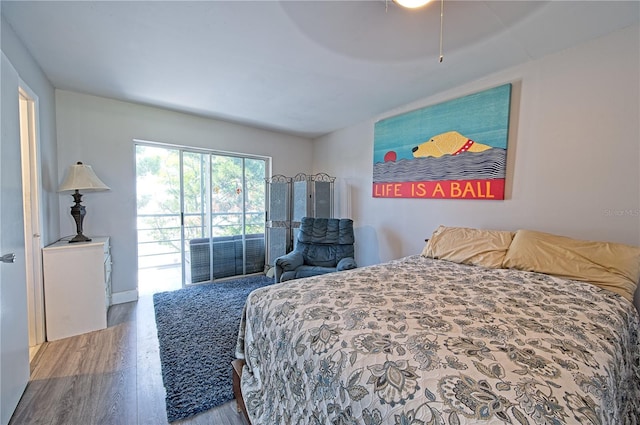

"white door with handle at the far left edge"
[0, 54, 29, 425]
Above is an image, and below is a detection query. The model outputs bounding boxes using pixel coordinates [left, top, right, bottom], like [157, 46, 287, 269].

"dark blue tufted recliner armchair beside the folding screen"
[275, 217, 357, 282]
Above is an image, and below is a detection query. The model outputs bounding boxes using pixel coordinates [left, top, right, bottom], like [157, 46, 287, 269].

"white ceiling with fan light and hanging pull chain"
[0, 0, 640, 137]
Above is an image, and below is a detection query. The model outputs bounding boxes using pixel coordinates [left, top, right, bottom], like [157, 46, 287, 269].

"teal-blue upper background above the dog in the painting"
[373, 84, 511, 164]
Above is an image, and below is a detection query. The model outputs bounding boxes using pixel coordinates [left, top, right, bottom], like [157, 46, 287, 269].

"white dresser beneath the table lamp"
[42, 237, 111, 341]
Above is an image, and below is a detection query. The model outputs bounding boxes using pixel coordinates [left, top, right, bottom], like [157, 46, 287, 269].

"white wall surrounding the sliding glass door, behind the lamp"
[56, 90, 313, 302]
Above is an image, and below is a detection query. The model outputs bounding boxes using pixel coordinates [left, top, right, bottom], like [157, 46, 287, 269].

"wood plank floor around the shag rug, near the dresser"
[9, 296, 248, 425]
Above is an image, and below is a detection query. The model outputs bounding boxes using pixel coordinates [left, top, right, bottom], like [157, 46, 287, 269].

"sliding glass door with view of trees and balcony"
[136, 143, 268, 292]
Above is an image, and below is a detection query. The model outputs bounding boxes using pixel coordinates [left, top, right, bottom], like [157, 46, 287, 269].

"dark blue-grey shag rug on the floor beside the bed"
[153, 275, 274, 422]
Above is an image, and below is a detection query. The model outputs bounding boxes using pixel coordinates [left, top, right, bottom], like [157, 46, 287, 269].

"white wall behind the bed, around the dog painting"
[313, 25, 640, 308]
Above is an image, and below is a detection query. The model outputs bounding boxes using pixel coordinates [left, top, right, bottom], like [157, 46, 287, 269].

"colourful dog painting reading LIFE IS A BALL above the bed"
[373, 84, 511, 200]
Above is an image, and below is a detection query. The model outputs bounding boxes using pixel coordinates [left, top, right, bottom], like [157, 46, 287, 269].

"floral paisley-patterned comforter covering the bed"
[236, 255, 640, 425]
